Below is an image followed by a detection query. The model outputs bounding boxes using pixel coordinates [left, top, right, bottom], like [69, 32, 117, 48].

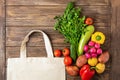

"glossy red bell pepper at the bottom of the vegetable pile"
[80, 64, 95, 80]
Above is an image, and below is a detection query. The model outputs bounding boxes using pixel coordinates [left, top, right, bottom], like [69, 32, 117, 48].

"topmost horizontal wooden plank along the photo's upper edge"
[6, 0, 109, 5]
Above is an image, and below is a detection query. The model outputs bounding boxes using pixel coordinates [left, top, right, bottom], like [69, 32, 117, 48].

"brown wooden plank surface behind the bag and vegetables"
[0, 0, 120, 80]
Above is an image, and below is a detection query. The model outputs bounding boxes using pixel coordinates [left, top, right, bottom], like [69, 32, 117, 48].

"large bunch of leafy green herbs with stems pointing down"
[54, 2, 86, 61]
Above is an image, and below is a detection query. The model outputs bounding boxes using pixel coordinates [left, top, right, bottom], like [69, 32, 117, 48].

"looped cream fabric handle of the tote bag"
[20, 30, 53, 58]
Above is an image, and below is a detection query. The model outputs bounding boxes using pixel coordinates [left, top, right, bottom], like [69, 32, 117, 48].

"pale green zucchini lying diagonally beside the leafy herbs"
[77, 25, 95, 56]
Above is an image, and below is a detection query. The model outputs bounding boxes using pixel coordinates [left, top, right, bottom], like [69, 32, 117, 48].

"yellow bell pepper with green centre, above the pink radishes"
[91, 32, 105, 44]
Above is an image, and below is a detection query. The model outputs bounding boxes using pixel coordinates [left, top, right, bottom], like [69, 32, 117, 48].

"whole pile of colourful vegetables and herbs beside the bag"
[54, 2, 110, 80]
